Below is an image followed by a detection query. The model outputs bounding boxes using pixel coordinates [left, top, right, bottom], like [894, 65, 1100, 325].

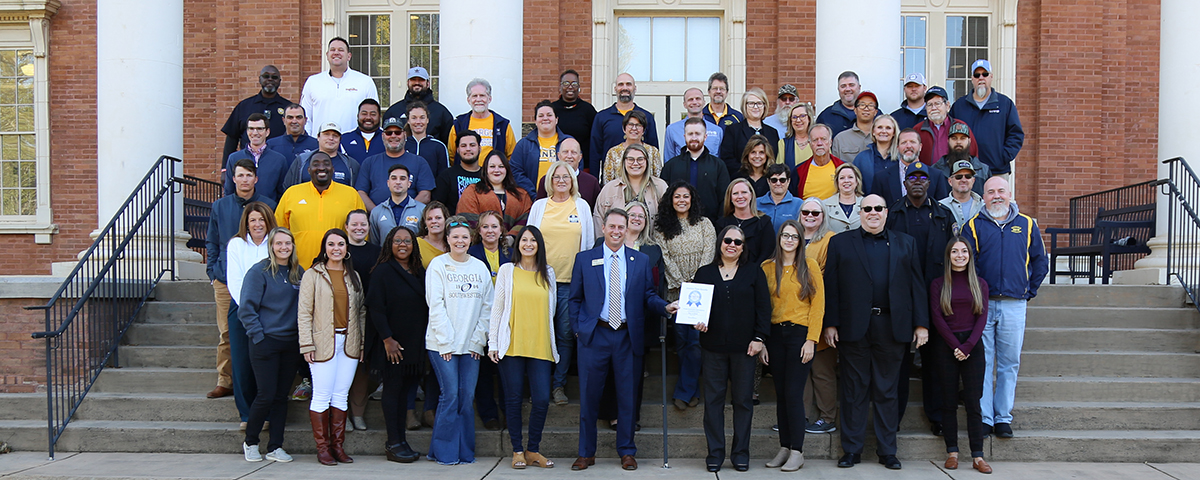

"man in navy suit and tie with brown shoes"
[571, 209, 679, 470]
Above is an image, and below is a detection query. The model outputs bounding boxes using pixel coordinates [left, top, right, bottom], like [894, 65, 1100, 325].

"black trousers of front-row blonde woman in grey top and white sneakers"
[245, 336, 300, 452]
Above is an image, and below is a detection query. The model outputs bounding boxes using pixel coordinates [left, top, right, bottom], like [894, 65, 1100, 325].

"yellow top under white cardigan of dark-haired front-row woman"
[505, 266, 554, 361]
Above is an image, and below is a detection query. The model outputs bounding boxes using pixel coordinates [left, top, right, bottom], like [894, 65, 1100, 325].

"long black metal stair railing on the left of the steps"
[25, 156, 192, 460]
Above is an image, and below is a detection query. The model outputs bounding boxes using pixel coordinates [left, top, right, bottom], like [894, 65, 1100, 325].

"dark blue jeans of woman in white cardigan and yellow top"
[498, 356, 554, 452]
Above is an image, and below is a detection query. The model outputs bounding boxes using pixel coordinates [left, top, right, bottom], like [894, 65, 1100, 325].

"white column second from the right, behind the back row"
[814, 0, 904, 110]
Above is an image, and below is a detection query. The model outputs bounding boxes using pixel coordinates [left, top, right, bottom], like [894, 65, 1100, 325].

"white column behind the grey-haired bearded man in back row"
[438, 0, 524, 125]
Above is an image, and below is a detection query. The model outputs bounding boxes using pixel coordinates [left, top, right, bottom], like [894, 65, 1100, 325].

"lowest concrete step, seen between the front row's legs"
[0, 420, 1200, 468]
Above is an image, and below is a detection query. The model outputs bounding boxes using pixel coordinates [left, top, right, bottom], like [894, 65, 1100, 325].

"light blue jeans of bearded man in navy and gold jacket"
[979, 299, 1027, 425]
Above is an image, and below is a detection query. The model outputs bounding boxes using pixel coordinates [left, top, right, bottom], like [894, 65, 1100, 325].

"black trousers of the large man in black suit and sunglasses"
[838, 314, 908, 455]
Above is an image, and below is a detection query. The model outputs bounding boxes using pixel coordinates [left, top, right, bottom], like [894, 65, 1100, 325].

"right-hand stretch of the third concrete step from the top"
[1024, 328, 1200, 353]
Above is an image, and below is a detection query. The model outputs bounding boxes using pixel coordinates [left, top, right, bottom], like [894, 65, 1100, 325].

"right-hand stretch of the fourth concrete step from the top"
[1020, 350, 1200, 378]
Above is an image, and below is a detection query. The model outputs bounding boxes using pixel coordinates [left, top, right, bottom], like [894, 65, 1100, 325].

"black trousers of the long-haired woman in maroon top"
[925, 331, 986, 457]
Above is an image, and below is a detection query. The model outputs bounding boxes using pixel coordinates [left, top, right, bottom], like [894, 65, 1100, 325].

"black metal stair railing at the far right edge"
[1163, 157, 1200, 310]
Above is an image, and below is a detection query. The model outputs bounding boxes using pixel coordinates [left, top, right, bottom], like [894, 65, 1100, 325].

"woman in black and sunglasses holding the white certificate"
[692, 226, 770, 472]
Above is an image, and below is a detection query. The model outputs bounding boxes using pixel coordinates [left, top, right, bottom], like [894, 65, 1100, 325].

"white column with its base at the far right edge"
[1114, 0, 1200, 283]
